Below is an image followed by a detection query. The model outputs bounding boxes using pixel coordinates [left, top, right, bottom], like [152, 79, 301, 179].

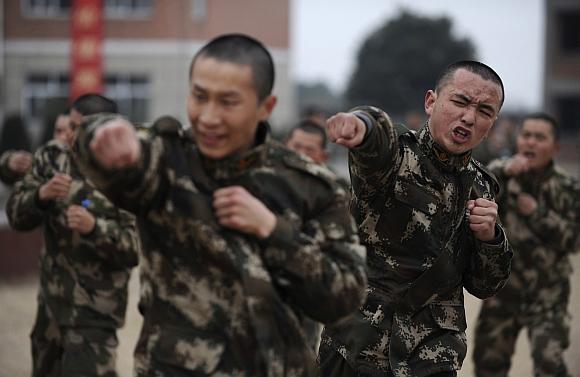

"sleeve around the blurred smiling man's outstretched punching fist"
[75, 115, 163, 214]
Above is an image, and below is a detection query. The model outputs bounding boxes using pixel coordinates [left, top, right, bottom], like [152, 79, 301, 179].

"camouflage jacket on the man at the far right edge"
[489, 159, 580, 315]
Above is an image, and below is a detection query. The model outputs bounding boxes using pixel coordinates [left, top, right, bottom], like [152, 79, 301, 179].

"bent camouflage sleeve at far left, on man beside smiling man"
[6, 147, 55, 231]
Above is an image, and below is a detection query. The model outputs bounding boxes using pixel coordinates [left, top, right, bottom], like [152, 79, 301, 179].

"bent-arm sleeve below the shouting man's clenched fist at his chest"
[463, 224, 513, 299]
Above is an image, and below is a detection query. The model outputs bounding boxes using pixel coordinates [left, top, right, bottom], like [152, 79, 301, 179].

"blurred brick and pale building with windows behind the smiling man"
[0, 0, 296, 142]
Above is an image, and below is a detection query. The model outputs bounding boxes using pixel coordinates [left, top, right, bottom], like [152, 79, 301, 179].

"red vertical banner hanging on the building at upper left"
[70, 0, 103, 101]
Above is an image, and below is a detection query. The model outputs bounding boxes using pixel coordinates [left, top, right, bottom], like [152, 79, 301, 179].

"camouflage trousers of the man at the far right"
[473, 297, 570, 377]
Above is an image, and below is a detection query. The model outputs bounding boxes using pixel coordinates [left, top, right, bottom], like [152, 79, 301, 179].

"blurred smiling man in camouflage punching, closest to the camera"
[71, 34, 366, 377]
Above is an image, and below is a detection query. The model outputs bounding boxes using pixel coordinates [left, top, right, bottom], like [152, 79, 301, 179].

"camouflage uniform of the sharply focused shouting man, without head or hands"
[319, 107, 511, 377]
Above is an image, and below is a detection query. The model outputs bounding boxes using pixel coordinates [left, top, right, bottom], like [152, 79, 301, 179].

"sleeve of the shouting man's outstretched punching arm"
[348, 106, 401, 199]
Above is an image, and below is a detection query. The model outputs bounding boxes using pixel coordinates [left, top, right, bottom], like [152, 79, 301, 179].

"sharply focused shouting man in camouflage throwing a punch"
[319, 61, 512, 377]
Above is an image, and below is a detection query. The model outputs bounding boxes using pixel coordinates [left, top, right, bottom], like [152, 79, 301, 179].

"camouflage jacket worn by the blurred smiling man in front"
[79, 117, 366, 376]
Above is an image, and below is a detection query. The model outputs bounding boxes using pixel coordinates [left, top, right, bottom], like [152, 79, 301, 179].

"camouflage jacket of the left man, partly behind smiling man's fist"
[6, 141, 139, 328]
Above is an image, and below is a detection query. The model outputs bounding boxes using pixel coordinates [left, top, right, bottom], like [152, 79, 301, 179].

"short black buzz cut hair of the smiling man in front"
[189, 34, 274, 101]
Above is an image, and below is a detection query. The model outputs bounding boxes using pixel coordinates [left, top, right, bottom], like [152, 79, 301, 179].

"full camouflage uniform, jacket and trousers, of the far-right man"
[473, 160, 580, 377]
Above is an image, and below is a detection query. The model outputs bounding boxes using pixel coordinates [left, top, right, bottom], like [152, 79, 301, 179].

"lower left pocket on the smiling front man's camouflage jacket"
[151, 327, 225, 375]
